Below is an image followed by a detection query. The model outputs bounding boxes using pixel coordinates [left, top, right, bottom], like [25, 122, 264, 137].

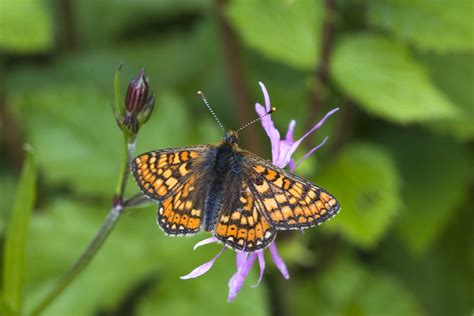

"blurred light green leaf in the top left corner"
[0, 0, 53, 53]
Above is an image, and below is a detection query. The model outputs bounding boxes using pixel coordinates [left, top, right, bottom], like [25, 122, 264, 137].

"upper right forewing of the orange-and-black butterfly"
[247, 155, 340, 230]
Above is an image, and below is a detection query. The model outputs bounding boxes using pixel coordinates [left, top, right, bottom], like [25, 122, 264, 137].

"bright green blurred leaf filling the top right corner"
[368, 0, 474, 52]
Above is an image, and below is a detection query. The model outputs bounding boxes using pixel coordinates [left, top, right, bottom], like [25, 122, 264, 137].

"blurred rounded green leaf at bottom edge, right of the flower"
[293, 256, 424, 316]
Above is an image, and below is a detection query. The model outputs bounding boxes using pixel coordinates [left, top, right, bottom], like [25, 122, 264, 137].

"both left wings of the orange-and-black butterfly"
[132, 145, 210, 235]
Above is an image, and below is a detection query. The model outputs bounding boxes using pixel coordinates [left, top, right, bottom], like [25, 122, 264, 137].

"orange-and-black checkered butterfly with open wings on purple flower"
[132, 131, 340, 252]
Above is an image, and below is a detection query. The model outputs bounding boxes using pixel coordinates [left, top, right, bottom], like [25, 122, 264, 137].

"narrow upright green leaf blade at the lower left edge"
[2, 147, 37, 315]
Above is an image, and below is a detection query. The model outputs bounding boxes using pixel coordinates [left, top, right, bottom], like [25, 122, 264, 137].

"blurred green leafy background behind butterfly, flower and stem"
[0, 0, 474, 316]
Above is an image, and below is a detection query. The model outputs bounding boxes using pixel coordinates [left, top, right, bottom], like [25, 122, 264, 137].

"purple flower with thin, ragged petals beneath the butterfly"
[181, 82, 339, 302]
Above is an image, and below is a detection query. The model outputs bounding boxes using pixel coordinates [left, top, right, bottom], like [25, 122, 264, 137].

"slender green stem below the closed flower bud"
[30, 135, 141, 315]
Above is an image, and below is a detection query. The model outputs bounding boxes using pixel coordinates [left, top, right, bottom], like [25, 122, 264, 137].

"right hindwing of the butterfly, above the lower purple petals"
[214, 183, 276, 252]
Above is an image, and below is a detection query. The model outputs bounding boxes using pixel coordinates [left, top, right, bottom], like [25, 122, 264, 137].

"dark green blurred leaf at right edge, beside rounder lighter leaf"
[380, 131, 472, 255]
